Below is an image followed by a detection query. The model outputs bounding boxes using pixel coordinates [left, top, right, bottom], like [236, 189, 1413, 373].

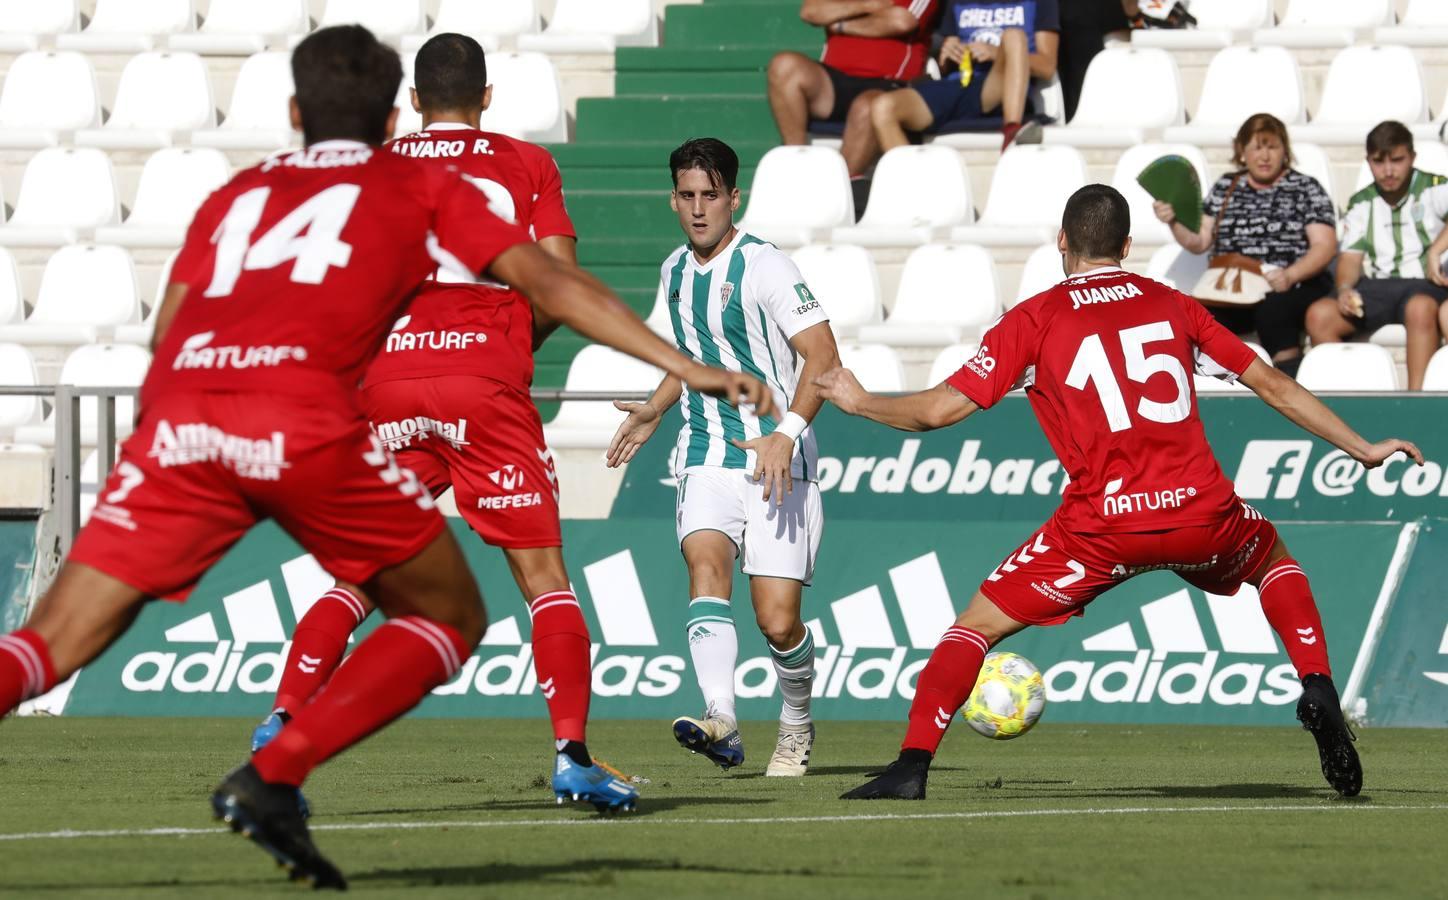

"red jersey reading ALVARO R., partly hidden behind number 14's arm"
[366, 123, 575, 391]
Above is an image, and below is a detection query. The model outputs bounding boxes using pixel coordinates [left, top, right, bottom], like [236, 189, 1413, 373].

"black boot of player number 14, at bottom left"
[211, 763, 348, 891]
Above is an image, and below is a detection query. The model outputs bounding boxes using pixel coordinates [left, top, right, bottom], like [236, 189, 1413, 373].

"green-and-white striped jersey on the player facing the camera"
[662, 232, 830, 480]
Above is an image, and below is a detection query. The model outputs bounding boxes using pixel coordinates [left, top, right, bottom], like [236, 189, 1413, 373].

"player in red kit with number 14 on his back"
[0, 26, 770, 887]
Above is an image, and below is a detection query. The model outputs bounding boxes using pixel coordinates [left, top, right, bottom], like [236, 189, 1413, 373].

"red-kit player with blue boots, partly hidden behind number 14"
[252, 33, 639, 809]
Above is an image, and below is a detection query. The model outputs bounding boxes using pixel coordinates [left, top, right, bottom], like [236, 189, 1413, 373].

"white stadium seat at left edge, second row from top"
[0, 51, 100, 149]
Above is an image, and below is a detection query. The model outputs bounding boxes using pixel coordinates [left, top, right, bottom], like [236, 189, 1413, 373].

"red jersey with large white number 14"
[142, 140, 529, 404]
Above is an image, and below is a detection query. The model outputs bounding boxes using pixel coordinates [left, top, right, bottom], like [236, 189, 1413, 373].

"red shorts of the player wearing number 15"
[980, 504, 1277, 625]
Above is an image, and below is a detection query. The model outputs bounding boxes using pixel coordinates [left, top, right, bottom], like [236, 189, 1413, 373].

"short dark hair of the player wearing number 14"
[291, 25, 403, 143]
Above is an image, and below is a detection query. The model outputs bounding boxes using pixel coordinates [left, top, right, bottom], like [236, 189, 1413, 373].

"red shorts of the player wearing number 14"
[70, 392, 446, 599]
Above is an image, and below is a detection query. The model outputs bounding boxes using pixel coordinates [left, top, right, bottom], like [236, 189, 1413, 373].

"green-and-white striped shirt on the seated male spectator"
[1341, 169, 1448, 278]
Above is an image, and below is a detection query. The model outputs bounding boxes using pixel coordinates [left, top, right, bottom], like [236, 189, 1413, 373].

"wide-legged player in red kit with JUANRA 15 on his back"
[821, 184, 1423, 800]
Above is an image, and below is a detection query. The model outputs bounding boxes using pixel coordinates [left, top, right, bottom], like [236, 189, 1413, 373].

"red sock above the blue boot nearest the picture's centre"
[529, 590, 592, 744]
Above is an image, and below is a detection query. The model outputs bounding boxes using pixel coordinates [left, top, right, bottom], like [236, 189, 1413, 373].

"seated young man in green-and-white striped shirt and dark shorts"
[1308, 122, 1448, 391]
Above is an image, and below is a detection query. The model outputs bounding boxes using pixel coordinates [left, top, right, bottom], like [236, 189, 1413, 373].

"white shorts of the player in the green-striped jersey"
[675, 466, 824, 586]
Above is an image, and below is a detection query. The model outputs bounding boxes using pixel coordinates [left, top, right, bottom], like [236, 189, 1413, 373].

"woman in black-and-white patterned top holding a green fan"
[1156, 113, 1337, 375]
